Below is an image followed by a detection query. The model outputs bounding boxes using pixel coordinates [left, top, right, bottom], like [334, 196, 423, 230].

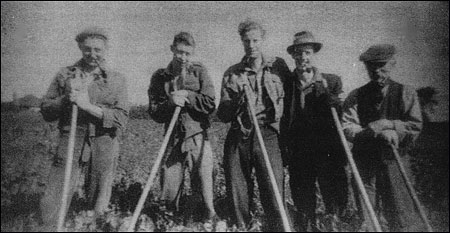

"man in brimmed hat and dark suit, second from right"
[281, 31, 348, 231]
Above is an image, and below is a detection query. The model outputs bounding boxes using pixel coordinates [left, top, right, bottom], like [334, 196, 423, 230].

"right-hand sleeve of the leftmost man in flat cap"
[101, 75, 130, 130]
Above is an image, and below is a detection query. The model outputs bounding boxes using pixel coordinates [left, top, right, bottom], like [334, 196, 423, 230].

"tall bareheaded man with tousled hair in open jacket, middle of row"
[217, 19, 290, 231]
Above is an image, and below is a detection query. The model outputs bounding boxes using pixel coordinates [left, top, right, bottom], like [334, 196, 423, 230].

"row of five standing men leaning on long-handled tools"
[40, 20, 422, 231]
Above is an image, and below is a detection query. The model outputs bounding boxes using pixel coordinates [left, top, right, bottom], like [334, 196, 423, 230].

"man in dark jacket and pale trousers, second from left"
[148, 32, 216, 221]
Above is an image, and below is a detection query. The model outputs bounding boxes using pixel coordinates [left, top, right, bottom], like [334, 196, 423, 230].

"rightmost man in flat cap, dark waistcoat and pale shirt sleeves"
[342, 44, 425, 231]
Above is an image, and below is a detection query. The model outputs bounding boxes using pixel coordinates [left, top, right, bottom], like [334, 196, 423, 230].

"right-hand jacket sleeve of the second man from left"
[187, 67, 216, 115]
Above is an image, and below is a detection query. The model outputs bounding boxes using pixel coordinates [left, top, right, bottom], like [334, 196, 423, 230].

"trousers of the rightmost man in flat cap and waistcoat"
[354, 145, 426, 232]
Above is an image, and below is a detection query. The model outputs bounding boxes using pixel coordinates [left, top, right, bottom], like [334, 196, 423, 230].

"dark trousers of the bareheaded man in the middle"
[224, 126, 284, 231]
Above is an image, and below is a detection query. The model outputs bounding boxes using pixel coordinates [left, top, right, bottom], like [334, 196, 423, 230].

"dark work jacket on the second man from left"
[148, 62, 216, 138]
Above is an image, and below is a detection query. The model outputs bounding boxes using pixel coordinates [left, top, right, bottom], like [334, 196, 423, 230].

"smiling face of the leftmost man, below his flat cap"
[79, 37, 106, 67]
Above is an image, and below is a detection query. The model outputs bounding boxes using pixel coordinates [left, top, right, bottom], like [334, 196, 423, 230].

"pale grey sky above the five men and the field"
[1, 1, 449, 119]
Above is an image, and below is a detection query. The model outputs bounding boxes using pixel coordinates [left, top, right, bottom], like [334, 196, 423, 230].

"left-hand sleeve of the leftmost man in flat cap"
[41, 70, 69, 121]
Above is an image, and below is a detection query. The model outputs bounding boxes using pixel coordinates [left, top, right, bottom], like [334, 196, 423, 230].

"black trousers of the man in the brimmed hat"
[289, 136, 348, 227]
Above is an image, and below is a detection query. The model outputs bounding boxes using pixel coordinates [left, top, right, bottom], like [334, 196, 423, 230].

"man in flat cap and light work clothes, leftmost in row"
[40, 27, 129, 227]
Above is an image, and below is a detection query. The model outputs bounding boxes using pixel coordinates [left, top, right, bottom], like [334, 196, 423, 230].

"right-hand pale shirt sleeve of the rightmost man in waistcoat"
[393, 86, 422, 145]
